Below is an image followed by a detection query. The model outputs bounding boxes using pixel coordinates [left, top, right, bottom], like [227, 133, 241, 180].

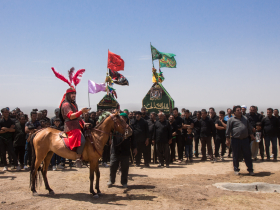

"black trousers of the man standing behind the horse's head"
[110, 154, 129, 185]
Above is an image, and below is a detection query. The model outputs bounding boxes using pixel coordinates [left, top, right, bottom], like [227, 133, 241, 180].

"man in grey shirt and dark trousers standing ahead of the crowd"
[226, 105, 255, 176]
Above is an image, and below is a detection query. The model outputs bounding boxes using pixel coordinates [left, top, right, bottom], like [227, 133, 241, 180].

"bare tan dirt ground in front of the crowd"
[0, 155, 280, 209]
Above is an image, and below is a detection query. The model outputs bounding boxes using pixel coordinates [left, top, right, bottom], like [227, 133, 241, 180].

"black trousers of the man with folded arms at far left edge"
[0, 139, 18, 166]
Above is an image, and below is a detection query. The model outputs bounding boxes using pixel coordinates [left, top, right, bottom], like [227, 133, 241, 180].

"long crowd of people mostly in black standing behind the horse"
[0, 105, 280, 179]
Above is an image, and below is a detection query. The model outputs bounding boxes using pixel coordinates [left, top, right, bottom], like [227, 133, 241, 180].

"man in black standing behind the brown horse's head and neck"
[107, 113, 137, 188]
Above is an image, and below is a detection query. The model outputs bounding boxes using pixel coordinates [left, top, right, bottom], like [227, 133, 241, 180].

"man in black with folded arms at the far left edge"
[0, 108, 20, 171]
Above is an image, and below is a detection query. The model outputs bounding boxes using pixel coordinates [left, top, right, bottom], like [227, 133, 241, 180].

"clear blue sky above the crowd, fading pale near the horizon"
[0, 0, 280, 113]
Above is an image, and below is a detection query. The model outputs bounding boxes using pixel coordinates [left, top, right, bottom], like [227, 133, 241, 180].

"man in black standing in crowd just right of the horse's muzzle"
[131, 111, 149, 167]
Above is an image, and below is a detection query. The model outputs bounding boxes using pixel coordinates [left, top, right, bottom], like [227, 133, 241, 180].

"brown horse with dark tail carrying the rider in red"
[30, 113, 132, 198]
